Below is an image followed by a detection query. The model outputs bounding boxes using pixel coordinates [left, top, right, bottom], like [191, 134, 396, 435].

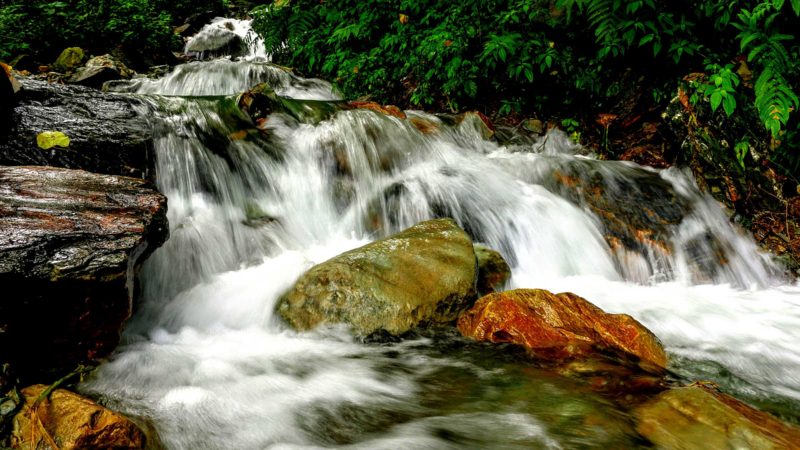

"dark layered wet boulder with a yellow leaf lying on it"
[0, 80, 154, 178]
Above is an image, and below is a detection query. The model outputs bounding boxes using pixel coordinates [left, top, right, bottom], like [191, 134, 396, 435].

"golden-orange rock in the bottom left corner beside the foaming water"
[11, 384, 145, 450]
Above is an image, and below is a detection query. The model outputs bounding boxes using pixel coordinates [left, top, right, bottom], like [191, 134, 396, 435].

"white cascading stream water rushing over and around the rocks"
[83, 22, 800, 449]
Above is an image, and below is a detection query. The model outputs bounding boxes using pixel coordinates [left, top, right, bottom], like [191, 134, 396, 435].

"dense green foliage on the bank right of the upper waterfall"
[252, 0, 800, 148]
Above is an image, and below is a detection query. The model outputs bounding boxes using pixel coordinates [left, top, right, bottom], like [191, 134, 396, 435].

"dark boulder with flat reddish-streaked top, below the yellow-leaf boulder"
[0, 166, 169, 381]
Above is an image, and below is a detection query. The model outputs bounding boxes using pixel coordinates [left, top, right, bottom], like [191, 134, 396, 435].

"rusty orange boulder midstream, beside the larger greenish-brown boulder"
[458, 289, 667, 371]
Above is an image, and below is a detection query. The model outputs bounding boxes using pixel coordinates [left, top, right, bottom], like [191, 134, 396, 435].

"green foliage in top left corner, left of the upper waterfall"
[0, 0, 223, 63]
